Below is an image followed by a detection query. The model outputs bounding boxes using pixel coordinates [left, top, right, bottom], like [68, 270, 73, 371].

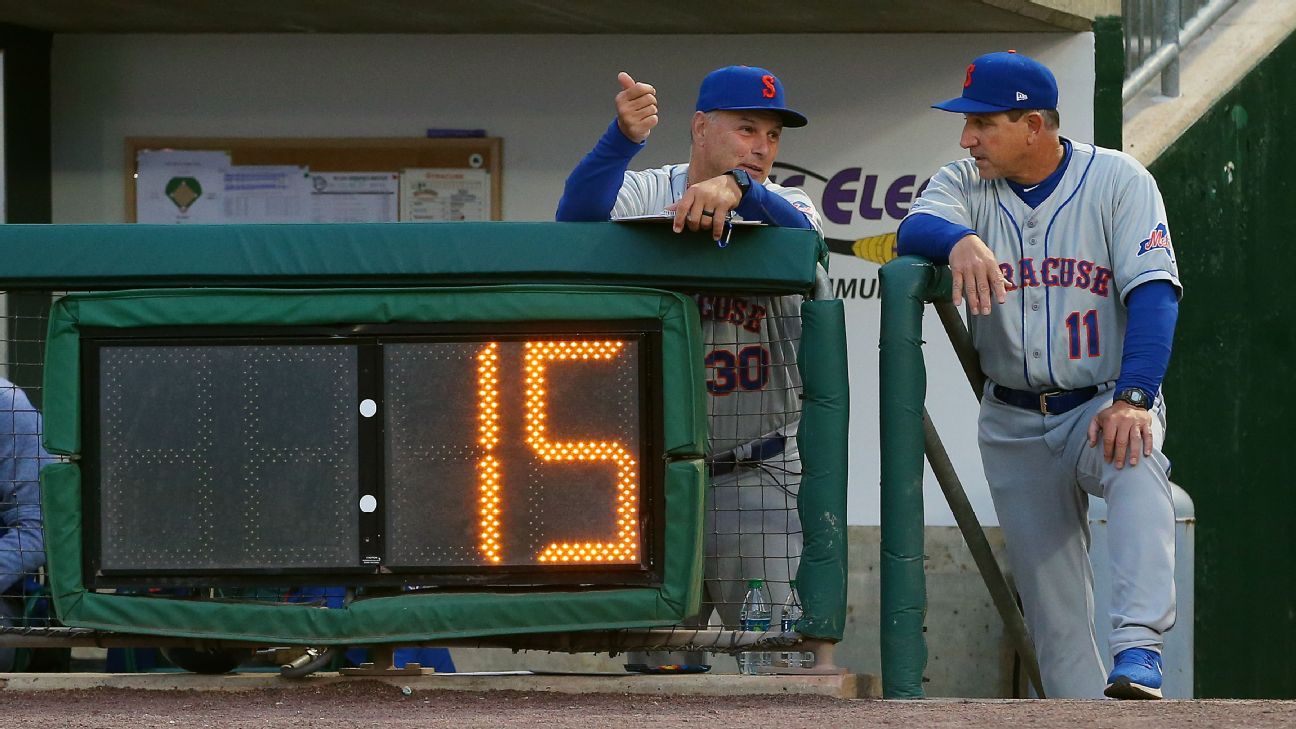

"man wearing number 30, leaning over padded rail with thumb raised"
[556, 66, 822, 627]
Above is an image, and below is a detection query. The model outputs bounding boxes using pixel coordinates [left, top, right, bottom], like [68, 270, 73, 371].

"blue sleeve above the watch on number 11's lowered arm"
[1116, 280, 1179, 397]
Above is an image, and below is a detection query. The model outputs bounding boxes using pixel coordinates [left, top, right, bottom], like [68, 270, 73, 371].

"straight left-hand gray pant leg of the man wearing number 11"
[978, 394, 1107, 698]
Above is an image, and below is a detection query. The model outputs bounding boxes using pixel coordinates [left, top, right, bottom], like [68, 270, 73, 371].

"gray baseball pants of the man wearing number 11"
[978, 383, 1174, 698]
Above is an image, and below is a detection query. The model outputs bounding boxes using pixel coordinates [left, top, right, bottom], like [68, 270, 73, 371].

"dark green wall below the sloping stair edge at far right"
[1148, 29, 1296, 699]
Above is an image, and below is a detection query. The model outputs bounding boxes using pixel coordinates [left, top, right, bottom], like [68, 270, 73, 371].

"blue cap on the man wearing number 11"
[932, 51, 1058, 114]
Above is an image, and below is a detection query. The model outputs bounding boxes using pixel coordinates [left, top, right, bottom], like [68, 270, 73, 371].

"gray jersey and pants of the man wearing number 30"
[612, 165, 823, 628]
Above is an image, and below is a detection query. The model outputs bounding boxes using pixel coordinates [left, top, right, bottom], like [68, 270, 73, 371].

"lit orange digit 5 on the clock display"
[524, 341, 639, 564]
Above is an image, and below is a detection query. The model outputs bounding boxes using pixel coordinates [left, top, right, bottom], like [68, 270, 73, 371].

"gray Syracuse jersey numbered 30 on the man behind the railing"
[612, 165, 823, 453]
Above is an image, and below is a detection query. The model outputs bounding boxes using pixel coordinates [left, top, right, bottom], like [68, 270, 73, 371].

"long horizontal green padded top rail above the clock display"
[0, 222, 828, 293]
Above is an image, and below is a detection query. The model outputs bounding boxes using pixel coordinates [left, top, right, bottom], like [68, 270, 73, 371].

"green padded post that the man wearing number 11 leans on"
[879, 256, 950, 699]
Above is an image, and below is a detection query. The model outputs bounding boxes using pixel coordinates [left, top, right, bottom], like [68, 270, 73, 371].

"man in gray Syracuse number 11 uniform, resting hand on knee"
[898, 51, 1182, 699]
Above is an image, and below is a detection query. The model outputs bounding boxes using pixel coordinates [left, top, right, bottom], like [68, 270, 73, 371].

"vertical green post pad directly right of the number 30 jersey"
[797, 300, 850, 641]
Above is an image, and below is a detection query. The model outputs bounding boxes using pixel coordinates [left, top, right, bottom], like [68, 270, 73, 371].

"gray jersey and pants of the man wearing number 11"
[910, 143, 1181, 698]
